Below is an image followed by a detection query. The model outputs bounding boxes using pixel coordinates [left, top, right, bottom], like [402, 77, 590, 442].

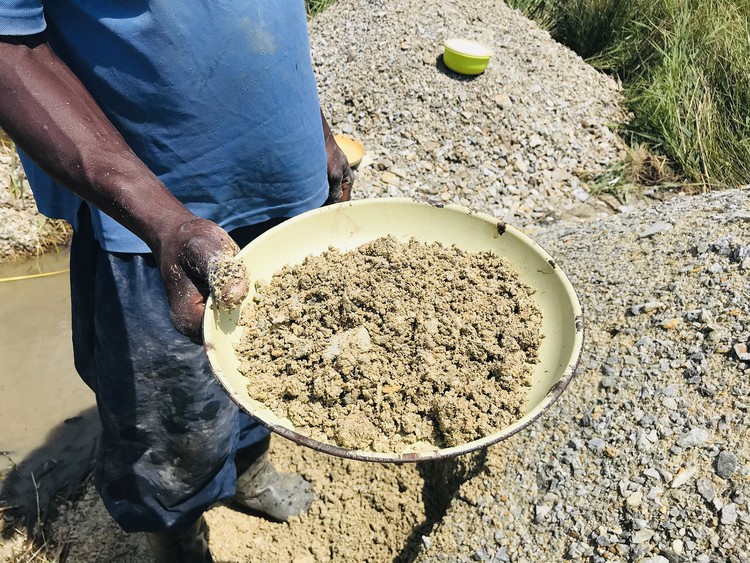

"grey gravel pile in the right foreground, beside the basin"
[418, 189, 750, 563]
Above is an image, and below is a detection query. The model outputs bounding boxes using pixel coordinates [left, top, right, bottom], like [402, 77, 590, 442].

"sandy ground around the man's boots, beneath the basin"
[39, 439, 488, 563]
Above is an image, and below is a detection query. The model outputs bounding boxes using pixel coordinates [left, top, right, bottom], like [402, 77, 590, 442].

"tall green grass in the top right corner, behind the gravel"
[510, 0, 750, 188]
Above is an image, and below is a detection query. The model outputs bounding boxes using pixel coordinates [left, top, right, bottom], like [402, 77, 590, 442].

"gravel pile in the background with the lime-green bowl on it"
[310, 0, 626, 229]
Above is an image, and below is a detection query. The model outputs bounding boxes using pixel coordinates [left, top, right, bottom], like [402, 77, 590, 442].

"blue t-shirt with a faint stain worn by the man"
[0, 0, 328, 252]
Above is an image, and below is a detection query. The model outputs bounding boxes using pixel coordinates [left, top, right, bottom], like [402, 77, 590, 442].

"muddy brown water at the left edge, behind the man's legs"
[0, 252, 98, 511]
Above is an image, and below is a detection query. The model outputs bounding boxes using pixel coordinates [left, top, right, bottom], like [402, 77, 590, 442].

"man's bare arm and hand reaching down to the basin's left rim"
[0, 35, 247, 341]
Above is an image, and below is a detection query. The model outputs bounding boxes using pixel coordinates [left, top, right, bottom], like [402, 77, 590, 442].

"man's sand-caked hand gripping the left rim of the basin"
[154, 217, 249, 344]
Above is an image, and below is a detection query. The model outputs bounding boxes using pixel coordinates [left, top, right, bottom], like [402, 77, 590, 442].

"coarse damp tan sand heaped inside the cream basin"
[237, 237, 542, 452]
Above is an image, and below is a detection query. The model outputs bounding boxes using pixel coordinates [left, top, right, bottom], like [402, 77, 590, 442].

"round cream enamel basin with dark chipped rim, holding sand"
[203, 198, 583, 462]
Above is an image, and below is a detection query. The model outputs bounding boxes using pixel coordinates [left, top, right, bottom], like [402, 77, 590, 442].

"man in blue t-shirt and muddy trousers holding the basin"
[0, 0, 352, 562]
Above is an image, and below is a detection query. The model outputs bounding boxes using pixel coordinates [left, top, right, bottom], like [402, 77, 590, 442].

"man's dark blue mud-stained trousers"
[70, 205, 280, 532]
